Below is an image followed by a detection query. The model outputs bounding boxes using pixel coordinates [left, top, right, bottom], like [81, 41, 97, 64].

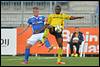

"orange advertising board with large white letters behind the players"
[17, 28, 99, 54]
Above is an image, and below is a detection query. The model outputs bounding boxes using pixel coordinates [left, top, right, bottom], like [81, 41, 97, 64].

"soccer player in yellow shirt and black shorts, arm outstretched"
[41, 5, 83, 64]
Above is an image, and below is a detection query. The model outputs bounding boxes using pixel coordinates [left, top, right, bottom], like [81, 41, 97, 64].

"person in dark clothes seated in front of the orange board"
[69, 27, 84, 56]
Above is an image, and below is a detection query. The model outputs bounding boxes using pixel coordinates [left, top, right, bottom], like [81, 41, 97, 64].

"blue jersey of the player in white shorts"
[28, 15, 45, 33]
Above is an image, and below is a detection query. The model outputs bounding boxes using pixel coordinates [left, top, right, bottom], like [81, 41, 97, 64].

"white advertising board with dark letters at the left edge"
[1, 29, 16, 55]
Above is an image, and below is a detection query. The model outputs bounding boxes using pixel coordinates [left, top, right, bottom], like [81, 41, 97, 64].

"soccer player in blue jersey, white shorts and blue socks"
[23, 7, 52, 64]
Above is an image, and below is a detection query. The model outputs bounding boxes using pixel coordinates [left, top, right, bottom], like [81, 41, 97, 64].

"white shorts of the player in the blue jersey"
[27, 33, 44, 45]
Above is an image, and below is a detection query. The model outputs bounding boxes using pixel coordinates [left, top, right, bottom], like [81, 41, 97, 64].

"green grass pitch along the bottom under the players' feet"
[1, 56, 99, 66]
